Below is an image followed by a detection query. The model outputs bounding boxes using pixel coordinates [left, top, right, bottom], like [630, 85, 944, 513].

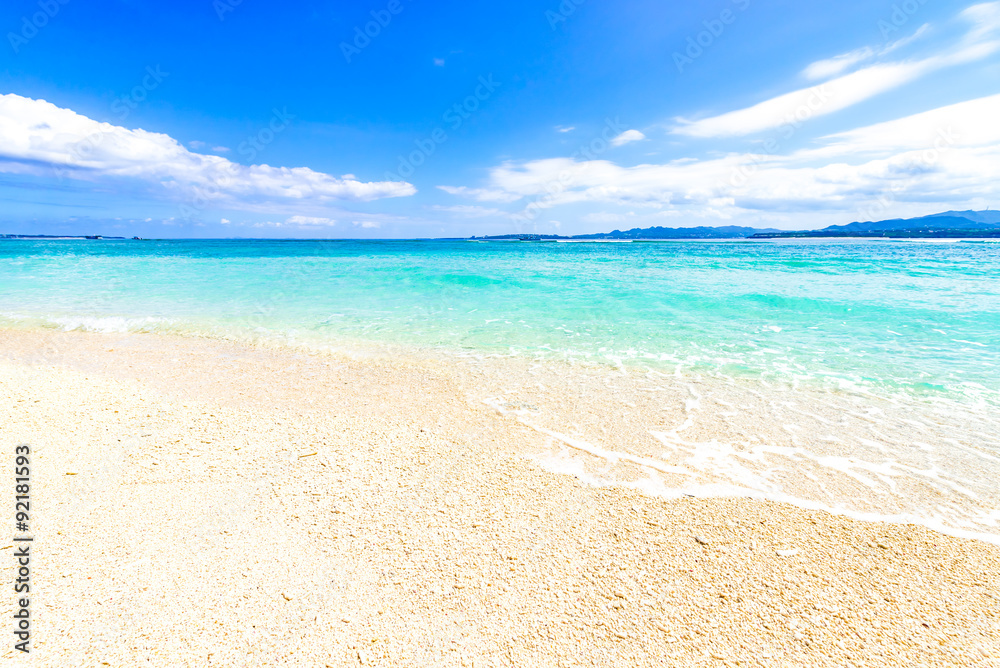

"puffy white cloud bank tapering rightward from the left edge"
[0, 94, 416, 209]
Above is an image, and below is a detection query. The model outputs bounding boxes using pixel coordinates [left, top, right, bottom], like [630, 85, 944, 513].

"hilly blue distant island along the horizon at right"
[472, 210, 1000, 241]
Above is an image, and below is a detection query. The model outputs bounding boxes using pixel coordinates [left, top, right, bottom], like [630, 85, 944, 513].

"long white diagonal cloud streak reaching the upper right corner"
[672, 2, 1000, 137]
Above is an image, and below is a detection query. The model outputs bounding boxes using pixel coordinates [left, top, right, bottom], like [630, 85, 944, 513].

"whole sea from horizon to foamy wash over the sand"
[0, 239, 1000, 542]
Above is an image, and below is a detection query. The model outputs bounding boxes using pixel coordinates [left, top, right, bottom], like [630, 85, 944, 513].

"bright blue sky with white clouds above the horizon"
[0, 0, 1000, 238]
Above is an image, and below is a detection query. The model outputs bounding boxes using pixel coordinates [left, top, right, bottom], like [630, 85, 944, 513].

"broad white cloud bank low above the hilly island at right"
[448, 95, 1000, 222]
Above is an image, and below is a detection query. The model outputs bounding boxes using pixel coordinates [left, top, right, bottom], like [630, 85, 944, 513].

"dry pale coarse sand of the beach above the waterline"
[0, 330, 1000, 667]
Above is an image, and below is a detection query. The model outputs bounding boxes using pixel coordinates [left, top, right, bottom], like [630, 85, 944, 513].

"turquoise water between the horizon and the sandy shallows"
[0, 240, 1000, 401]
